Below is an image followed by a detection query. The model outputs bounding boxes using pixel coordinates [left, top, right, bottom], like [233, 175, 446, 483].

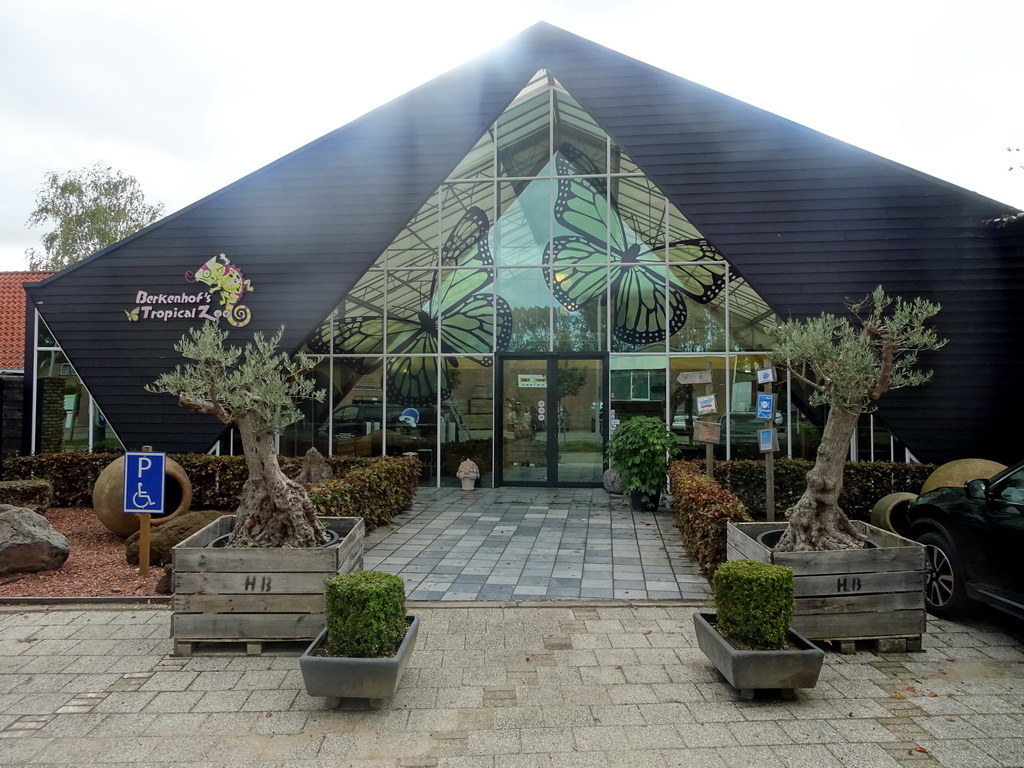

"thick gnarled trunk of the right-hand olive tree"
[775, 408, 865, 552]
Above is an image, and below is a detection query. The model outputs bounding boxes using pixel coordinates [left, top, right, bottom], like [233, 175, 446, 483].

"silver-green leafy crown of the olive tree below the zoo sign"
[146, 323, 326, 434]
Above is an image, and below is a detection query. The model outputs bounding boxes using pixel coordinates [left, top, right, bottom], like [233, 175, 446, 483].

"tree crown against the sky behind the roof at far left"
[25, 163, 164, 269]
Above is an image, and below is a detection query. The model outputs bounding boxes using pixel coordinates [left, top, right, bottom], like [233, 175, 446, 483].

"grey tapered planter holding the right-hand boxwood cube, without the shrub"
[693, 612, 825, 699]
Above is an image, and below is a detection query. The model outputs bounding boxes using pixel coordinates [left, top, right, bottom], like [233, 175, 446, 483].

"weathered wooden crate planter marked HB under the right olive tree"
[728, 520, 927, 652]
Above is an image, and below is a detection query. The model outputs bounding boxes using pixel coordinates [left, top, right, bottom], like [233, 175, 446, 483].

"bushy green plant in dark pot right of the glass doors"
[607, 416, 676, 512]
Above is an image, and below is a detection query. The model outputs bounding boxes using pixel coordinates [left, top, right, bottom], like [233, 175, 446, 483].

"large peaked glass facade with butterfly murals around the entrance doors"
[297, 71, 802, 484]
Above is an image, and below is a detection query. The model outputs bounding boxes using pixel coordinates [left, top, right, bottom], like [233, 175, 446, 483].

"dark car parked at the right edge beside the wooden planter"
[898, 462, 1024, 618]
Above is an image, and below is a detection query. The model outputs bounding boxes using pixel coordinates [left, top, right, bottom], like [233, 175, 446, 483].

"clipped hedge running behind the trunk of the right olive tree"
[679, 459, 935, 522]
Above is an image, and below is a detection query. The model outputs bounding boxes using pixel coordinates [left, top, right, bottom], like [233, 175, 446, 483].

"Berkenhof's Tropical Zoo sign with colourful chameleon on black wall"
[125, 254, 254, 328]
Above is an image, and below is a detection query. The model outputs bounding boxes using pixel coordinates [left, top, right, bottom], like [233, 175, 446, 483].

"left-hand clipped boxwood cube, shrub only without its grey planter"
[324, 570, 408, 658]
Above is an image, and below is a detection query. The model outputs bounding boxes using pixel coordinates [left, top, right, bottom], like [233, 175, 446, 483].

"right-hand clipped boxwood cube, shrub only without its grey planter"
[714, 560, 794, 649]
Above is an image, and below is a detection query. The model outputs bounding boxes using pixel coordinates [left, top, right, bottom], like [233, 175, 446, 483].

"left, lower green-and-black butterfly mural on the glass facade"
[307, 206, 512, 408]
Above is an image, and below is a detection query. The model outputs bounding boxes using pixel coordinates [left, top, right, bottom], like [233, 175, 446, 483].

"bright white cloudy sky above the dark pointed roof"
[0, 0, 1024, 270]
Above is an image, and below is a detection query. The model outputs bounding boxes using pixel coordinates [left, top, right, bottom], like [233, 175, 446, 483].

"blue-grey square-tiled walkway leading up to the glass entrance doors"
[364, 487, 711, 601]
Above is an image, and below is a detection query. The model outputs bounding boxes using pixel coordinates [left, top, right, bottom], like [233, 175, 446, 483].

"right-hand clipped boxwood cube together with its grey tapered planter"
[693, 560, 824, 699]
